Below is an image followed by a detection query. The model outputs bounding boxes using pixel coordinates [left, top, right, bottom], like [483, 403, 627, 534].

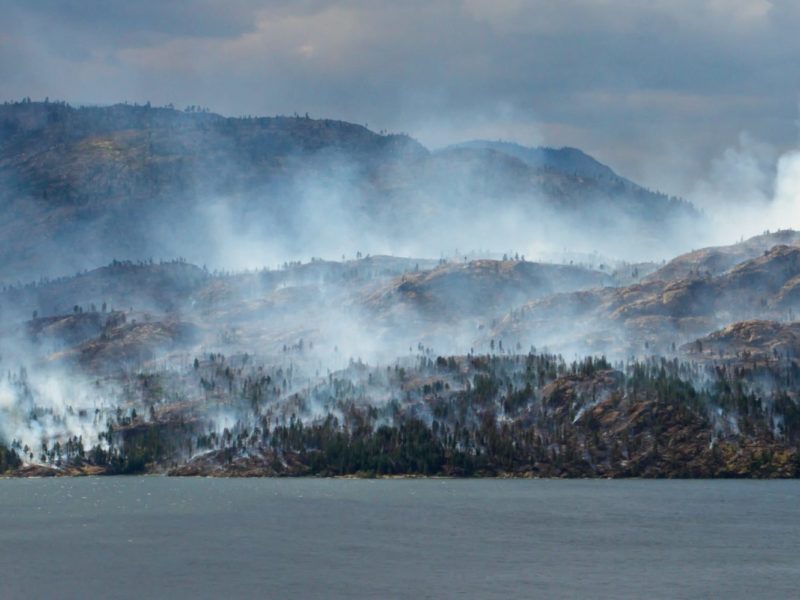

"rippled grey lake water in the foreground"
[0, 477, 800, 599]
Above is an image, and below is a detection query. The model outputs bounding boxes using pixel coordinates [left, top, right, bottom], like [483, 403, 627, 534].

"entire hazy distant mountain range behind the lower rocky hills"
[0, 102, 701, 283]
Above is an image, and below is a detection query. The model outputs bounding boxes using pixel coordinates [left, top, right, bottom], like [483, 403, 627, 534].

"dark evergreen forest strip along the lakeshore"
[6, 353, 800, 477]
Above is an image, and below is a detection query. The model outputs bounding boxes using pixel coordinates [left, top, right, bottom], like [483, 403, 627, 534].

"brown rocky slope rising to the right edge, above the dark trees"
[491, 232, 800, 354]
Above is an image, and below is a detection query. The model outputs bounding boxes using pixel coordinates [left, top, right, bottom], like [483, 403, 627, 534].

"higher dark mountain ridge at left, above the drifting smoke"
[0, 103, 428, 281]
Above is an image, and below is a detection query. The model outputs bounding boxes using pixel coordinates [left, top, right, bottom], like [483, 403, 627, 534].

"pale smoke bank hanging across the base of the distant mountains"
[161, 144, 697, 271]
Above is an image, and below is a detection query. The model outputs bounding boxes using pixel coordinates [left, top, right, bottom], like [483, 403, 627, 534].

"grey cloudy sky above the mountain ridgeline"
[0, 0, 800, 193]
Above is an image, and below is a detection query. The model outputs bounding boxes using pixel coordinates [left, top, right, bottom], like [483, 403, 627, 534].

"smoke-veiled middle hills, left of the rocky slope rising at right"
[0, 256, 613, 372]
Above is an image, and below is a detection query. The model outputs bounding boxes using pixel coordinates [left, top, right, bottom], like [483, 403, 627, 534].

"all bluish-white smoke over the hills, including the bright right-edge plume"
[0, 102, 800, 468]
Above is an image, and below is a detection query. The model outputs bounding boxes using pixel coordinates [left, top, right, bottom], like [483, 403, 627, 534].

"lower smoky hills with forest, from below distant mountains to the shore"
[0, 230, 800, 477]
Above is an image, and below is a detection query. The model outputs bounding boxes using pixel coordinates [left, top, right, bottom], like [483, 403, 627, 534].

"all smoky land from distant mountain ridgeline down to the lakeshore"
[0, 100, 800, 477]
